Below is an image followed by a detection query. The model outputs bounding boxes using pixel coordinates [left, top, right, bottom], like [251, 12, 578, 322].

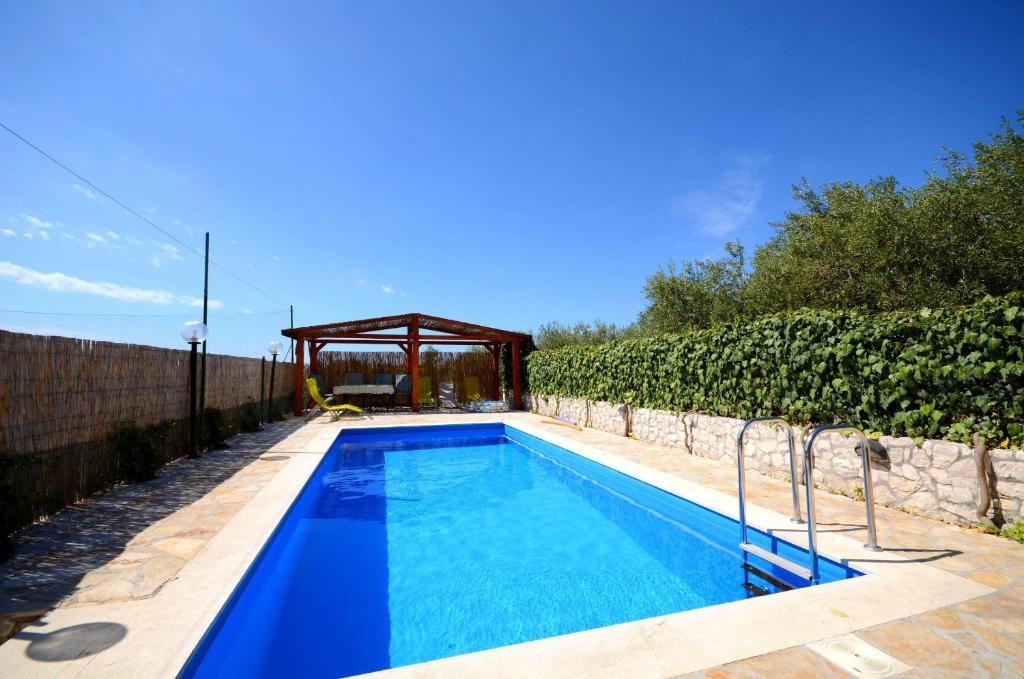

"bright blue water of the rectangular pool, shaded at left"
[182, 424, 859, 677]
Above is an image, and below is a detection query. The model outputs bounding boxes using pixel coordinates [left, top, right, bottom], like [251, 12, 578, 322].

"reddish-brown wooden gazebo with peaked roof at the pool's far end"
[281, 313, 530, 415]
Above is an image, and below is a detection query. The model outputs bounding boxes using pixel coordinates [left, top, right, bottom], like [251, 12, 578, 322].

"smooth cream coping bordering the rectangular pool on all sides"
[0, 414, 994, 679]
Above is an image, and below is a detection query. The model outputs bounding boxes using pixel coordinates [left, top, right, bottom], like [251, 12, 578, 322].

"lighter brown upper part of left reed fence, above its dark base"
[0, 330, 293, 455]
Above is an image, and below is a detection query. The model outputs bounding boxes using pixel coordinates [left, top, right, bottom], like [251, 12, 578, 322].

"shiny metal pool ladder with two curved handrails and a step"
[736, 416, 882, 586]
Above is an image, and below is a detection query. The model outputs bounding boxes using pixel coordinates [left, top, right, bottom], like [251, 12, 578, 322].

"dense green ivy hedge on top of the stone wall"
[527, 293, 1024, 447]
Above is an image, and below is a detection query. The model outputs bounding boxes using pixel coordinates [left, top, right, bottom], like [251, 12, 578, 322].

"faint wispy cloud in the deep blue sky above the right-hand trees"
[674, 155, 768, 237]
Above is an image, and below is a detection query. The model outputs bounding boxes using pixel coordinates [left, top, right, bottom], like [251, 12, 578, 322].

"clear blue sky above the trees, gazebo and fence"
[0, 1, 1024, 355]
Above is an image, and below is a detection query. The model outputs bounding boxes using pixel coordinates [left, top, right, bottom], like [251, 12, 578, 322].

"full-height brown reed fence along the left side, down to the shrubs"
[0, 331, 294, 536]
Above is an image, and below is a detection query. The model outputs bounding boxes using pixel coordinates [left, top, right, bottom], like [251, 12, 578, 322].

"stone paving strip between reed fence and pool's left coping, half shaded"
[0, 419, 303, 640]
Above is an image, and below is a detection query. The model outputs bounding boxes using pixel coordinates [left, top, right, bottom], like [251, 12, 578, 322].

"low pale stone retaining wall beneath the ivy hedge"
[523, 394, 1024, 524]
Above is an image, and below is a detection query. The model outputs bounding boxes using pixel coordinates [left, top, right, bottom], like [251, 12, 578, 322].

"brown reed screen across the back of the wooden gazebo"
[317, 349, 495, 402]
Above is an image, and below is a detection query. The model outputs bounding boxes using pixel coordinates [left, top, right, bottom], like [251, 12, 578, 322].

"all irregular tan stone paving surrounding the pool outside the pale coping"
[0, 414, 1024, 677]
